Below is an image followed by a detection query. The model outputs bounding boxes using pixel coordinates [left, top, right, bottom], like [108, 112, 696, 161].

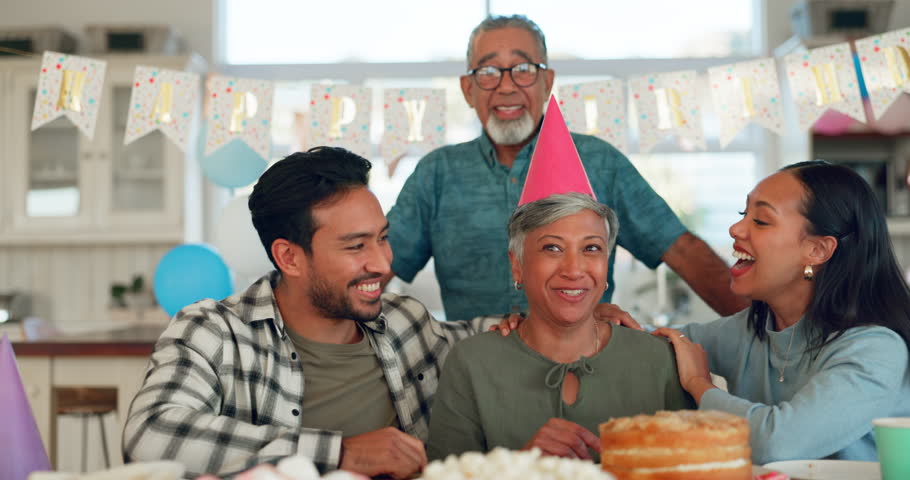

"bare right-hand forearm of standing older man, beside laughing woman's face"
[661, 232, 749, 317]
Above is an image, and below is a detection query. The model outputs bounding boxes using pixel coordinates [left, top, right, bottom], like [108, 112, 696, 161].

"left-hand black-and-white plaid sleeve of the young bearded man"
[123, 314, 341, 478]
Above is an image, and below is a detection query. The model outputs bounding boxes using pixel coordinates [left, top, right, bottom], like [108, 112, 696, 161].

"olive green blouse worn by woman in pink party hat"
[427, 326, 695, 460]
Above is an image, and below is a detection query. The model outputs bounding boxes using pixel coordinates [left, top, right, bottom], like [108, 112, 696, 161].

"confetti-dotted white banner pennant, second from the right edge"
[784, 43, 866, 130]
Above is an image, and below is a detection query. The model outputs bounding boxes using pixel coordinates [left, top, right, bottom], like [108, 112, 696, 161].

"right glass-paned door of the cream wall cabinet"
[96, 64, 183, 235]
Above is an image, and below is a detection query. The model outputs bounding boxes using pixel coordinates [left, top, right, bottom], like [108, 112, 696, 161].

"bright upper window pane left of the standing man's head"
[224, 0, 484, 64]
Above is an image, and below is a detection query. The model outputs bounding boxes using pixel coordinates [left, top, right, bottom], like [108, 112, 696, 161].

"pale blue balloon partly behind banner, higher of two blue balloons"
[199, 136, 269, 188]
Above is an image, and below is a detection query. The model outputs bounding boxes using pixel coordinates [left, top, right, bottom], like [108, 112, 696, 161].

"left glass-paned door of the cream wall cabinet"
[6, 62, 95, 233]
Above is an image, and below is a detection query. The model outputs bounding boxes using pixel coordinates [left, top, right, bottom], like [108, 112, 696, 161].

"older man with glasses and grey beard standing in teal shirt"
[389, 15, 747, 320]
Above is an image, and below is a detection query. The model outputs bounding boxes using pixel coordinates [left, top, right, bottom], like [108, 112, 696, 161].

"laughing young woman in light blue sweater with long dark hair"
[655, 161, 910, 463]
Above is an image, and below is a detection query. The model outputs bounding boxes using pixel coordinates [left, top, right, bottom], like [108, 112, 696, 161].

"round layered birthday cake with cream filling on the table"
[600, 410, 752, 480]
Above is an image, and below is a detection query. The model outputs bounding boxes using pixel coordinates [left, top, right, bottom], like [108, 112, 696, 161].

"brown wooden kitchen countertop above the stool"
[13, 325, 165, 357]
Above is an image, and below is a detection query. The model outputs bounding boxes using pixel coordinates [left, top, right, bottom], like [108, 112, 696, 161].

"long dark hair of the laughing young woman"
[749, 160, 910, 352]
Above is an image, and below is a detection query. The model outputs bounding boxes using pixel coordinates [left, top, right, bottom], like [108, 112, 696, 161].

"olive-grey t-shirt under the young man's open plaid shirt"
[287, 327, 398, 437]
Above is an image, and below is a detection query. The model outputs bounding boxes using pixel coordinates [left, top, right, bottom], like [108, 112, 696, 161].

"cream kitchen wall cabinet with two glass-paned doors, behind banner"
[0, 55, 203, 245]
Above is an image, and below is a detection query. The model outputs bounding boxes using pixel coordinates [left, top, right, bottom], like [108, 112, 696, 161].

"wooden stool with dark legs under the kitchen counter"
[55, 387, 117, 472]
